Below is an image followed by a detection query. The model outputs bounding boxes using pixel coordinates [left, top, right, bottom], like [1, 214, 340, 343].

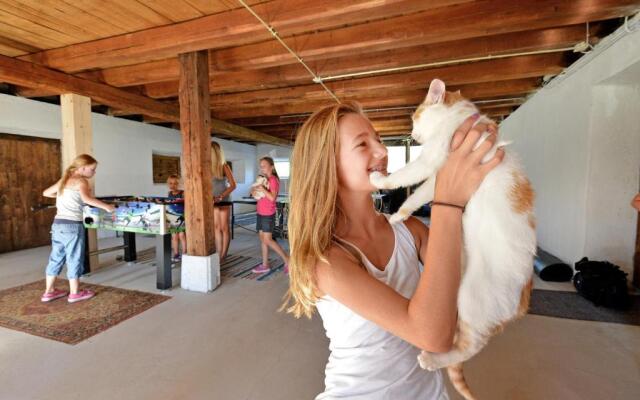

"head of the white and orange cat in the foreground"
[411, 79, 474, 143]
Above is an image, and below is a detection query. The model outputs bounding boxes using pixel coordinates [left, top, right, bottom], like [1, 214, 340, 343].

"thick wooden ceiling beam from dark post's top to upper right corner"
[211, 0, 638, 70]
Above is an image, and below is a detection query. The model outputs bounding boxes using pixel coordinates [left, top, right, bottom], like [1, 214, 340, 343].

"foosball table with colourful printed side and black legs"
[83, 196, 232, 290]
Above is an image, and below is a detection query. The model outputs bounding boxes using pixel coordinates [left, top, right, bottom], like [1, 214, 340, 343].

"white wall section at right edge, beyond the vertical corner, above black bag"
[584, 72, 640, 272]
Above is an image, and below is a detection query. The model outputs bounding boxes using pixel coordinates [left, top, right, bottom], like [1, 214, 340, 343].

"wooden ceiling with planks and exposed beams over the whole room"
[0, 0, 640, 143]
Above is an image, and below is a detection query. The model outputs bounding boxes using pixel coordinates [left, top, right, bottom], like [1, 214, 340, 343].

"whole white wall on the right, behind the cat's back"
[500, 23, 640, 271]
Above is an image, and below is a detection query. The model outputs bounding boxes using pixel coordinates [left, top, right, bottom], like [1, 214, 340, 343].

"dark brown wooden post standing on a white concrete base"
[179, 51, 215, 256]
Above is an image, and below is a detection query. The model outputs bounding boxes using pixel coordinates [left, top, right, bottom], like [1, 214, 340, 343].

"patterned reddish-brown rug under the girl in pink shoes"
[0, 279, 171, 344]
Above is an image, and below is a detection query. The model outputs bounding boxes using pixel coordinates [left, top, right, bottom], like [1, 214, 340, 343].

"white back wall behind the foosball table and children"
[0, 94, 290, 219]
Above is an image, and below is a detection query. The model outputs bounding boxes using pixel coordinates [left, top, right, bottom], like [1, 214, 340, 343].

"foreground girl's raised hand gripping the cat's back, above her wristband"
[434, 115, 504, 207]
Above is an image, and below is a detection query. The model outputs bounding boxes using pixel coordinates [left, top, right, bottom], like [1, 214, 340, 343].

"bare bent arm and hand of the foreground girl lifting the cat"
[316, 116, 504, 352]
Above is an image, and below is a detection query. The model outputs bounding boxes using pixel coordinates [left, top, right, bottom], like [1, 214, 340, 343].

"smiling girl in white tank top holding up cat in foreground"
[288, 103, 503, 400]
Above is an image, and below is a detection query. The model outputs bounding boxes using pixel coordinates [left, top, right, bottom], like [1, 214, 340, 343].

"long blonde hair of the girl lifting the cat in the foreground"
[281, 103, 363, 318]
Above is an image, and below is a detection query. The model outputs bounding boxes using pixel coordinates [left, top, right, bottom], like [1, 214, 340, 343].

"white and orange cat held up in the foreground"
[371, 79, 536, 400]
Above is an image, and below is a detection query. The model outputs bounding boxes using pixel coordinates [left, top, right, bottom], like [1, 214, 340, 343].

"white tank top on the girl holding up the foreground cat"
[316, 219, 448, 400]
